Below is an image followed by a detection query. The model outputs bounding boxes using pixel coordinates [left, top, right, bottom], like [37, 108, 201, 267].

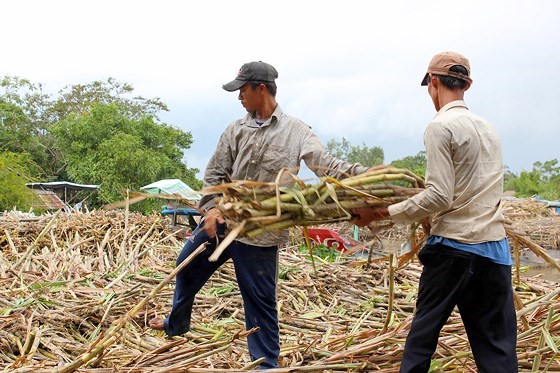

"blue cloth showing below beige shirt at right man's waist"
[426, 236, 512, 265]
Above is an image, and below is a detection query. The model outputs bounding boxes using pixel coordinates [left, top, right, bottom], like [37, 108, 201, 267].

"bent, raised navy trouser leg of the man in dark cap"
[164, 222, 229, 336]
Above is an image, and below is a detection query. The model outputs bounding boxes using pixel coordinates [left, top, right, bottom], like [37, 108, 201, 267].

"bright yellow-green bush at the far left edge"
[0, 151, 33, 211]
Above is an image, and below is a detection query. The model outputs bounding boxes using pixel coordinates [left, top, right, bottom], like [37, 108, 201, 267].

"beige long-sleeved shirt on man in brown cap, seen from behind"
[389, 101, 505, 244]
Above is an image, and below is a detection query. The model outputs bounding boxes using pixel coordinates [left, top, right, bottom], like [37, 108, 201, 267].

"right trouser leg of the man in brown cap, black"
[458, 257, 518, 373]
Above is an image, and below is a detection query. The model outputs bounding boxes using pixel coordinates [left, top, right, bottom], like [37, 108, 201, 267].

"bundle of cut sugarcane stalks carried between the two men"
[203, 167, 424, 237]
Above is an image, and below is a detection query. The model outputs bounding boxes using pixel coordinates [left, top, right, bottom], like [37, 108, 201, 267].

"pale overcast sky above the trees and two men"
[0, 0, 560, 177]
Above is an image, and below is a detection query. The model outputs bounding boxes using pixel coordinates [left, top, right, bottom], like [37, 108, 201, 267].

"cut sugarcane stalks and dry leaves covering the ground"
[0, 196, 560, 372]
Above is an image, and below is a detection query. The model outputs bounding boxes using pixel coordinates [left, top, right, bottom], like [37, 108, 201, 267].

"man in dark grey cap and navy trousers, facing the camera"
[150, 61, 368, 369]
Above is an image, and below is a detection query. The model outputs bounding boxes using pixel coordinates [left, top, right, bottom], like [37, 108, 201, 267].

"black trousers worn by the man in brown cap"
[400, 245, 518, 373]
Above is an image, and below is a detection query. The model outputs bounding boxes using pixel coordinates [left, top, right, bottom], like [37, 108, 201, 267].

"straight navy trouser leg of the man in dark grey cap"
[230, 241, 280, 368]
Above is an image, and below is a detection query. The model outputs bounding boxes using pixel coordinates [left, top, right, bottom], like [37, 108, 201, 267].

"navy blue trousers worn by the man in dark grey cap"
[165, 222, 280, 368]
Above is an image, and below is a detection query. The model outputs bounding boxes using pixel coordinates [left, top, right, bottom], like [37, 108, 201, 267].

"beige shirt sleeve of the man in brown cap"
[389, 122, 455, 224]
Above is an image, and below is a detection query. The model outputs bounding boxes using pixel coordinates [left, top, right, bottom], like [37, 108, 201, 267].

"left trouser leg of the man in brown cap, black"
[400, 245, 472, 372]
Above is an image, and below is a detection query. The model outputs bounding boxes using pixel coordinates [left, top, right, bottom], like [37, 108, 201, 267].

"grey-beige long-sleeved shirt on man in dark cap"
[200, 105, 368, 246]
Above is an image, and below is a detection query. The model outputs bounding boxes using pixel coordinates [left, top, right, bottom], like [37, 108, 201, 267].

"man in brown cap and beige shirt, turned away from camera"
[354, 52, 518, 373]
